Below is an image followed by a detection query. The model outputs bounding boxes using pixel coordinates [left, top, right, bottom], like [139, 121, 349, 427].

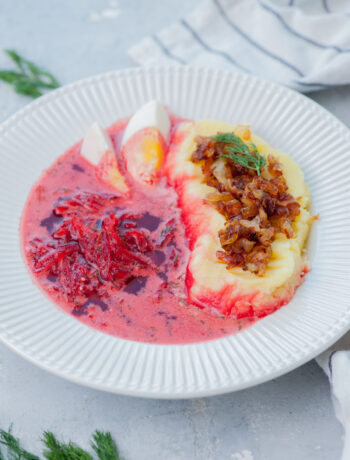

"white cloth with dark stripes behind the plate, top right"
[128, 0, 350, 92]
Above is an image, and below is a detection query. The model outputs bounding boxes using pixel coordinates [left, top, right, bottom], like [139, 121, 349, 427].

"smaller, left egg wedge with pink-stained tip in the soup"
[80, 122, 129, 194]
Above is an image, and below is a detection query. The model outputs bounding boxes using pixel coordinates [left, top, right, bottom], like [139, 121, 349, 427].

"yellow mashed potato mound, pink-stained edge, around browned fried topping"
[165, 120, 312, 318]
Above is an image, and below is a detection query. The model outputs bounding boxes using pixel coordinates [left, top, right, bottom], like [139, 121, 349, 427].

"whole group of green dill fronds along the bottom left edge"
[0, 427, 120, 460]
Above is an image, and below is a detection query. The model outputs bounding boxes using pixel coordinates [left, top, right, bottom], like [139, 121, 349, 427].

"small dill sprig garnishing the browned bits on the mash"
[212, 133, 266, 176]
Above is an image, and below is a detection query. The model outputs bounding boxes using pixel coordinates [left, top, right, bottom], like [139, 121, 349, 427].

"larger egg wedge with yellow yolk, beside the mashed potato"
[122, 101, 171, 185]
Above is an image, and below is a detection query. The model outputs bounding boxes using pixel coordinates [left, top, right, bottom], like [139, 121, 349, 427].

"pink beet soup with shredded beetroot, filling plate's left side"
[21, 116, 254, 344]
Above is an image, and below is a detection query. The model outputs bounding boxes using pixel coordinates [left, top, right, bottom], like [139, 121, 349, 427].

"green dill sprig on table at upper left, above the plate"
[0, 50, 60, 98]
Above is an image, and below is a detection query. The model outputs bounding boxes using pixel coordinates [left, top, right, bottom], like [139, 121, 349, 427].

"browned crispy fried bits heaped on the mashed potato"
[191, 136, 300, 276]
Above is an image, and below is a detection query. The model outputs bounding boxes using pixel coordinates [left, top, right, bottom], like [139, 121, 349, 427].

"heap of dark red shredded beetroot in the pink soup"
[30, 193, 155, 304]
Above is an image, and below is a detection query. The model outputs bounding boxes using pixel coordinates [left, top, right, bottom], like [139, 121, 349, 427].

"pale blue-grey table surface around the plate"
[0, 0, 350, 460]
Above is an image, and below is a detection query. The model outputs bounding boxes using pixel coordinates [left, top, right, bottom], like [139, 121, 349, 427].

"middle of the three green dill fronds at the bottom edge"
[43, 431, 93, 460]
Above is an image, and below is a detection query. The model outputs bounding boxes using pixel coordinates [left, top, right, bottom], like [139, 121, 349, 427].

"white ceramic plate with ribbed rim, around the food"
[0, 67, 350, 398]
